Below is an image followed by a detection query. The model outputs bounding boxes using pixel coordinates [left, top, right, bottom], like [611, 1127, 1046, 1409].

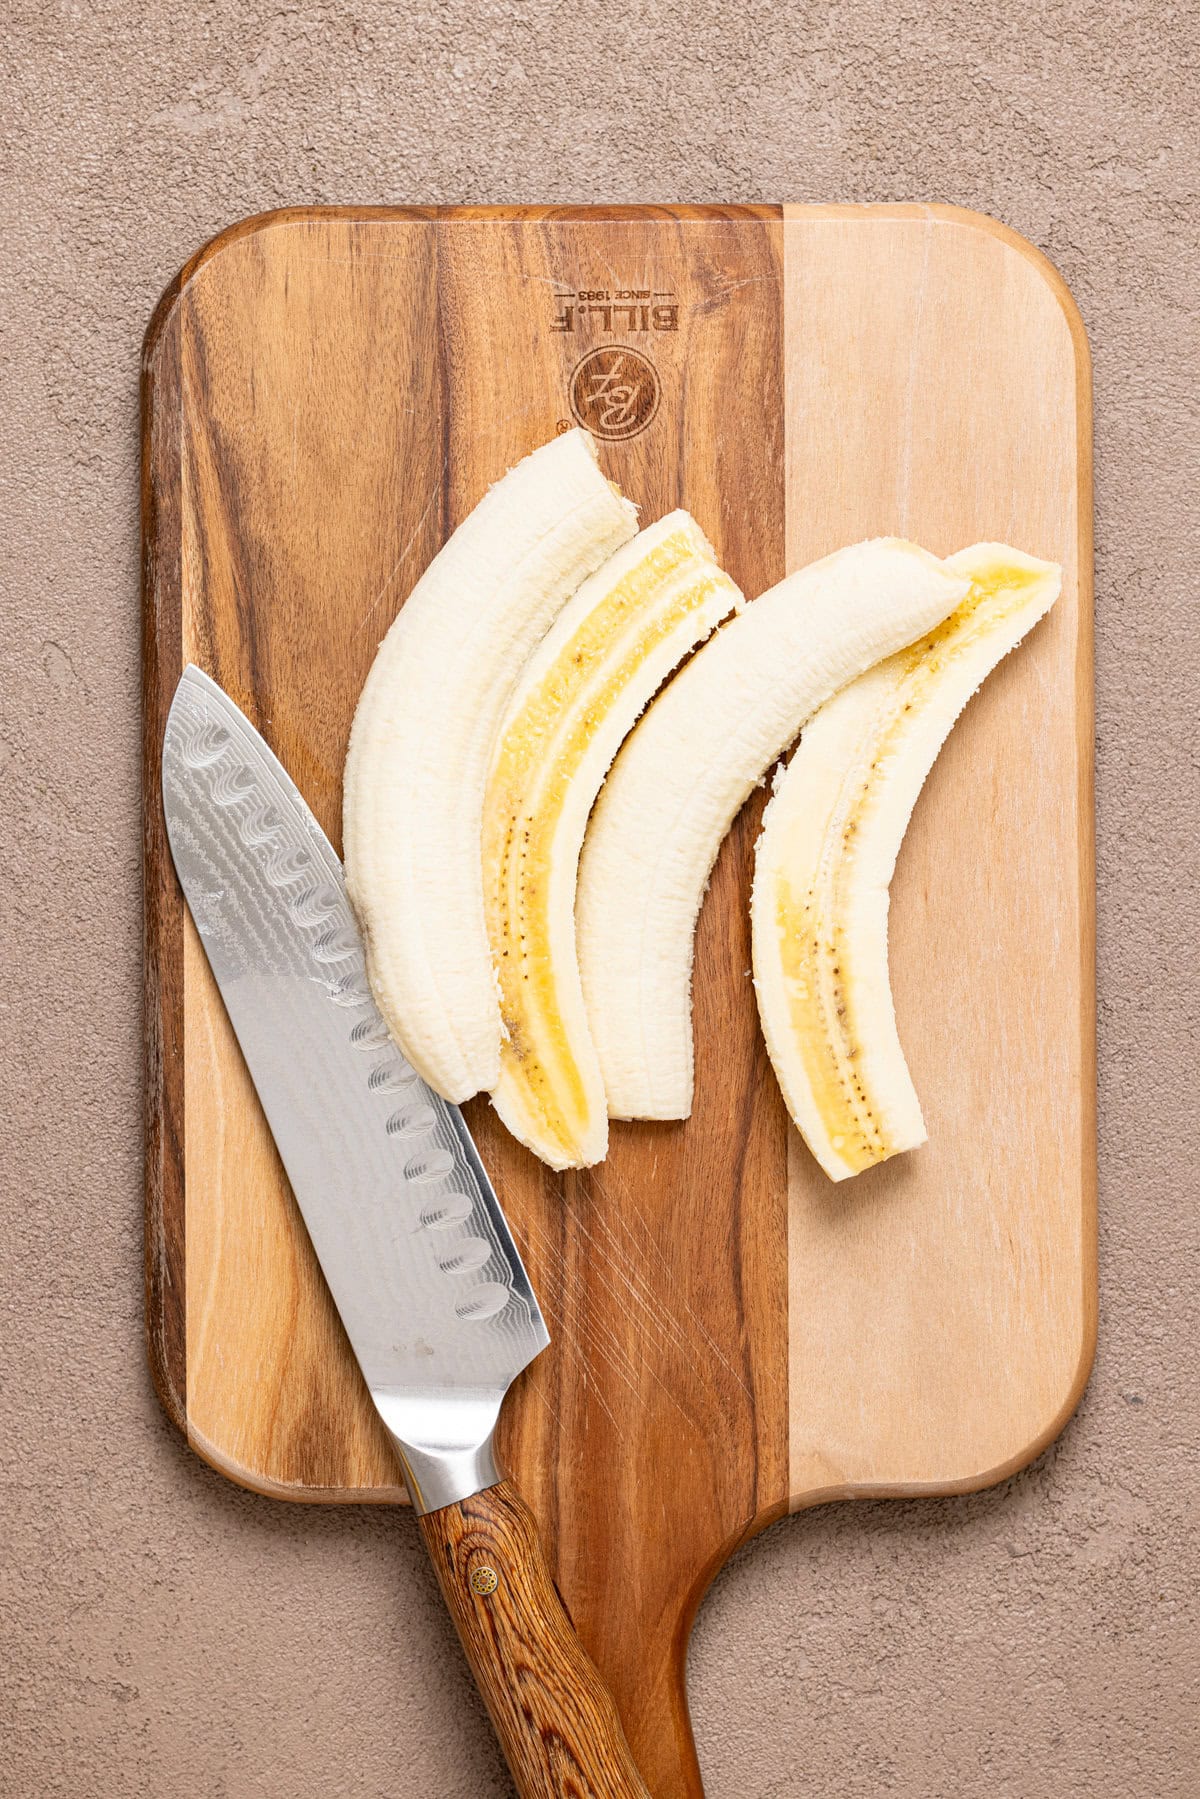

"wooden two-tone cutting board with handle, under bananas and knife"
[144, 207, 1096, 1799]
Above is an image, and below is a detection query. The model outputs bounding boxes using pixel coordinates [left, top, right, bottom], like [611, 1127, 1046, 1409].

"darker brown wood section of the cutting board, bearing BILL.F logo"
[148, 209, 788, 1794]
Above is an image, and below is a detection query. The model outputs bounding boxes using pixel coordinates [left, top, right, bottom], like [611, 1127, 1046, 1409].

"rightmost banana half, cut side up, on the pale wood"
[750, 543, 1061, 1180]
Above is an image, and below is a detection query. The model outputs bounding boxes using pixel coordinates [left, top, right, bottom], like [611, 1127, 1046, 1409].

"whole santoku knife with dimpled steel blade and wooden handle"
[162, 666, 649, 1799]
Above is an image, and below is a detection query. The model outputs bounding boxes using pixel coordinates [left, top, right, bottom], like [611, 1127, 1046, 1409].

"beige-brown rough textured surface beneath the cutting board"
[0, 0, 1200, 1799]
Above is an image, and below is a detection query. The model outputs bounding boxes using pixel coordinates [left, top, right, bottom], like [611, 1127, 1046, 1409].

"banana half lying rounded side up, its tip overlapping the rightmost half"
[578, 538, 966, 1119]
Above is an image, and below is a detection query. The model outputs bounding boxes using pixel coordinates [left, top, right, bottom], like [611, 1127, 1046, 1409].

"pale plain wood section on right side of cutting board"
[784, 209, 1094, 1506]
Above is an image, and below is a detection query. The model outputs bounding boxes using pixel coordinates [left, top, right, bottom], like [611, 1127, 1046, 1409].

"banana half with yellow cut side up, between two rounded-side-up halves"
[484, 513, 741, 1168]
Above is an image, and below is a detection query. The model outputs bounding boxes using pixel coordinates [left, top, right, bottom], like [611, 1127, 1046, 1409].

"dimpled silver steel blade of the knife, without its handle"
[162, 667, 549, 1437]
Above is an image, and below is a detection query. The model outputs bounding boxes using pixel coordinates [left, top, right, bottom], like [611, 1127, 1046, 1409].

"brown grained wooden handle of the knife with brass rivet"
[419, 1481, 649, 1799]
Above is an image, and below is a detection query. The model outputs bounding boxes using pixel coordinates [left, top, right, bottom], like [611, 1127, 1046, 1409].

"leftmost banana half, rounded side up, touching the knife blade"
[344, 432, 637, 1099]
